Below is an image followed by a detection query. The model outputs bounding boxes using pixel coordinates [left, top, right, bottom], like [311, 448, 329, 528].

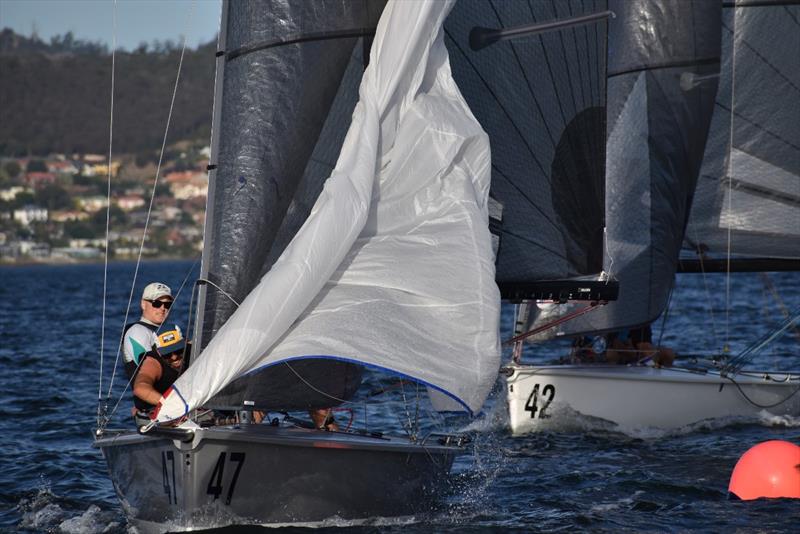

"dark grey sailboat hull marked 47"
[94, 425, 462, 532]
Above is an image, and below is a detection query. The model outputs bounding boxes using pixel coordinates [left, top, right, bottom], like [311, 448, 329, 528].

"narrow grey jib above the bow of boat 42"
[544, 0, 721, 334]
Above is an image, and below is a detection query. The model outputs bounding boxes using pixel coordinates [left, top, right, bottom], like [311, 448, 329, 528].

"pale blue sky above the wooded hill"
[0, 0, 221, 50]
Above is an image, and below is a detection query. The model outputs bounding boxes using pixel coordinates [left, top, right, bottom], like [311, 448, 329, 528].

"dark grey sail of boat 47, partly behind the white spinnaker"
[198, 0, 383, 409]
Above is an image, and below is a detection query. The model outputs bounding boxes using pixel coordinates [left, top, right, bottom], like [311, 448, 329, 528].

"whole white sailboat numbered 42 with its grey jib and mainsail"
[504, 1, 800, 434]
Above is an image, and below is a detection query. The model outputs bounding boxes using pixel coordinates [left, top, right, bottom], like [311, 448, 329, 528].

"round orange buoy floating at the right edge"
[728, 440, 800, 501]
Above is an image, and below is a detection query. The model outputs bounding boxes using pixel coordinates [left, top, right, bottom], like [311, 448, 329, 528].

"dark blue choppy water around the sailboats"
[0, 262, 800, 532]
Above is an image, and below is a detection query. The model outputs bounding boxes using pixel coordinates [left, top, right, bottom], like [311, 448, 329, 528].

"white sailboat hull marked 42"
[505, 365, 800, 434]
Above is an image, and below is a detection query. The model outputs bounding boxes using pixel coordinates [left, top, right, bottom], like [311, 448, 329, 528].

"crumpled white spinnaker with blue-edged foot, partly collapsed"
[157, 0, 500, 421]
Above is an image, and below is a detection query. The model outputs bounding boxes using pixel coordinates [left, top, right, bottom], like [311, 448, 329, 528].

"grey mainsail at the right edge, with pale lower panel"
[685, 0, 800, 271]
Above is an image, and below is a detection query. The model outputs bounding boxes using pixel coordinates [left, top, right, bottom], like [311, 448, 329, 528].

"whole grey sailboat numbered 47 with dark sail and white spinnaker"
[94, 0, 500, 531]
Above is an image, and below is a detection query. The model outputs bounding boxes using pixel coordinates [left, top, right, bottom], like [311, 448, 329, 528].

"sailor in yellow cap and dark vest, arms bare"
[133, 325, 186, 426]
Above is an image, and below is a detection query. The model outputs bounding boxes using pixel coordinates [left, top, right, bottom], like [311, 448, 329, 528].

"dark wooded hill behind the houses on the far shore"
[0, 29, 216, 156]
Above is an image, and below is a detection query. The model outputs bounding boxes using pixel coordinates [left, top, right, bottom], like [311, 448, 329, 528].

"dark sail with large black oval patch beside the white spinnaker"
[445, 0, 607, 299]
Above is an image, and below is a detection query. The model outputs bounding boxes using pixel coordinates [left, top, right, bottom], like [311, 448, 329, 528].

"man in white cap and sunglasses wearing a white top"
[122, 282, 173, 379]
